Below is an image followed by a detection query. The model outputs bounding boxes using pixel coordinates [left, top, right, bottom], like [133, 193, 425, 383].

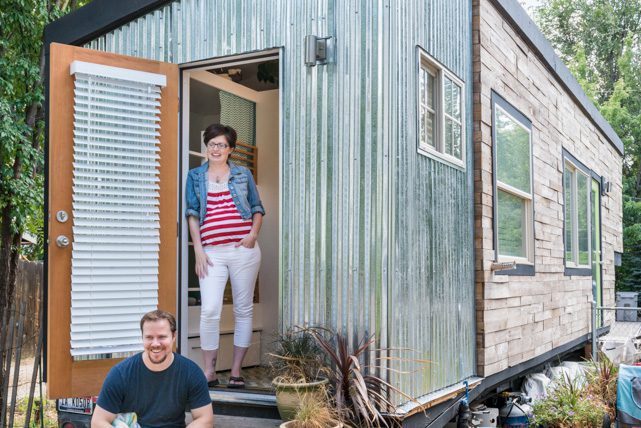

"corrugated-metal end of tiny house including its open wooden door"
[46, 0, 476, 416]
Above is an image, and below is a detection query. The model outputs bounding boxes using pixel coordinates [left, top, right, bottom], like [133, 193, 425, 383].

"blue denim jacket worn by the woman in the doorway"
[185, 162, 265, 225]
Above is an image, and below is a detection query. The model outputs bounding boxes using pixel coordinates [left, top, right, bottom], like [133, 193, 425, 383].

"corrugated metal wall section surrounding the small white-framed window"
[385, 0, 476, 396]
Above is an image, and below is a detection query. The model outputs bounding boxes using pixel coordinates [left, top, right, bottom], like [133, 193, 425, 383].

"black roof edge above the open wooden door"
[44, 0, 171, 46]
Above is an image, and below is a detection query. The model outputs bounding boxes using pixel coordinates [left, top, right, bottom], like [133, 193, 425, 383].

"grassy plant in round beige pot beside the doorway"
[270, 328, 329, 421]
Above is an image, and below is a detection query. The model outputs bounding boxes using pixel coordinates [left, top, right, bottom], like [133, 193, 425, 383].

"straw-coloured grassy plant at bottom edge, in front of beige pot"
[280, 386, 343, 428]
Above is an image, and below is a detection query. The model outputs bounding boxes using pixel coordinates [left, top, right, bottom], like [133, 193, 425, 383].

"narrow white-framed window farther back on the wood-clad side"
[563, 159, 590, 268]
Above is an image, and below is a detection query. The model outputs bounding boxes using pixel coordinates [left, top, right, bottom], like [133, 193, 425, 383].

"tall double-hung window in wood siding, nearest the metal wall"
[492, 94, 534, 274]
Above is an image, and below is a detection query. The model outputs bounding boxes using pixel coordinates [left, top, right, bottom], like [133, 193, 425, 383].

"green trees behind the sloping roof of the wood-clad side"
[536, 0, 641, 289]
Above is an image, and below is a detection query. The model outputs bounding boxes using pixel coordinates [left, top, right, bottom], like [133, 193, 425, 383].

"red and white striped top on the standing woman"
[200, 182, 252, 247]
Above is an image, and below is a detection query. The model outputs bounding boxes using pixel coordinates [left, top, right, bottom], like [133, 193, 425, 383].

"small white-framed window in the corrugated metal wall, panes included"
[418, 49, 465, 167]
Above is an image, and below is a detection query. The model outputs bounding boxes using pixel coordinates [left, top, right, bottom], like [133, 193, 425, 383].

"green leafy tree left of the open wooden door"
[0, 0, 86, 414]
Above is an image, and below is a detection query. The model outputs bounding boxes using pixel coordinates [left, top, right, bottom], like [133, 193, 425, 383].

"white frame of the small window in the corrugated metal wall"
[416, 46, 467, 170]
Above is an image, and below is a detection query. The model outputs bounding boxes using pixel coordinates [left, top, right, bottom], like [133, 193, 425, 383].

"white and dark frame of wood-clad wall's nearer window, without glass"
[491, 91, 535, 276]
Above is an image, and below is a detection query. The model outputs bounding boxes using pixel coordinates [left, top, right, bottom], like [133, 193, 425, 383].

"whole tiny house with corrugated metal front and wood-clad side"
[45, 0, 622, 426]
